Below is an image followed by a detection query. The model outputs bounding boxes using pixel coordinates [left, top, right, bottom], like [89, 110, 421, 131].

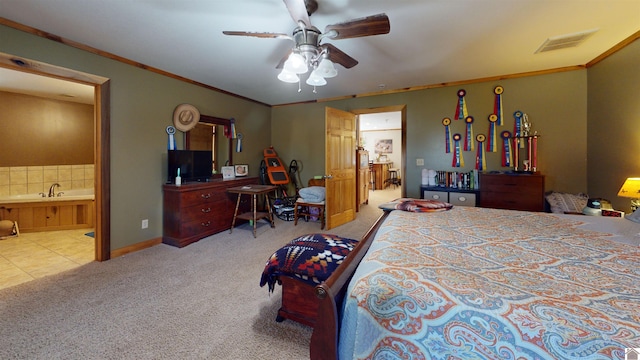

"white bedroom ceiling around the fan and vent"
[0, 0, 640, 105]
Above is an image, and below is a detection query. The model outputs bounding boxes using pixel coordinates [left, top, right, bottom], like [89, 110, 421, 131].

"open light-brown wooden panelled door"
[325, 107, 356, 230]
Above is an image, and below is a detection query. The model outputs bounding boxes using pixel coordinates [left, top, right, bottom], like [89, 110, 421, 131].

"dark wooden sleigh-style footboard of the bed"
[310, 212, 389, 360]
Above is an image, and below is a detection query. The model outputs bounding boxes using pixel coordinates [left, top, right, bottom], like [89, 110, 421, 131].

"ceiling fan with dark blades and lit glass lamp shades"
[223, 0, 391, 92]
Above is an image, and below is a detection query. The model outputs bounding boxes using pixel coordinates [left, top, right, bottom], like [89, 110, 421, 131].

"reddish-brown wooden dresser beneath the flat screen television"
[162, 177, 258, 247]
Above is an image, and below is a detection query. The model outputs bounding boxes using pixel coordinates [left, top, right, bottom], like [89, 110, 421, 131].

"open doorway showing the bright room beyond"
[351, 105, 406, 206]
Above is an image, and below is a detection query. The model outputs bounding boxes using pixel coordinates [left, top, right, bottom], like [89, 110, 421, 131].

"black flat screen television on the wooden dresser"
[167, 150, 213, 184]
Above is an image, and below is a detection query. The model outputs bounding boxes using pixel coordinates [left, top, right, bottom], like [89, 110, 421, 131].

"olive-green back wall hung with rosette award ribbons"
[271, 69, 587, 197]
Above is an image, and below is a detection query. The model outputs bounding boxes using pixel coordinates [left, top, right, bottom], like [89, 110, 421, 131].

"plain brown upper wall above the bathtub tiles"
[0, 91, 94, 167]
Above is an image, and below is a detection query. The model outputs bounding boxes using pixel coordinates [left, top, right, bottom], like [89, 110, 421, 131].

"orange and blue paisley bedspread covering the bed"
[339, 206, 640, 360]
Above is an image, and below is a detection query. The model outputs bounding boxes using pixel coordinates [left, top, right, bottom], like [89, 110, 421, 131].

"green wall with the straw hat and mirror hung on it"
[0, 26, 271, 250]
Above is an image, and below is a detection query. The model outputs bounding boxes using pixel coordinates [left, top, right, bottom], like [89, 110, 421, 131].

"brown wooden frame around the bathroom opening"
[0, 53, 111, 261]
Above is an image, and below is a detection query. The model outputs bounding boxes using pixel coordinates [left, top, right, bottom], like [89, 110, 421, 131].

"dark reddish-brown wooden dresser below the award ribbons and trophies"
[479, 174, 544, 211]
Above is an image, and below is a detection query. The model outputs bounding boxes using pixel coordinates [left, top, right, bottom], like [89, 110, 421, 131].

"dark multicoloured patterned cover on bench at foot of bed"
[260, 234, 358, 291]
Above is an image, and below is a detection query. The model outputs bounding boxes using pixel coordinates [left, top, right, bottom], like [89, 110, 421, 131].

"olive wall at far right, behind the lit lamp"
[587, 40, 640, 212]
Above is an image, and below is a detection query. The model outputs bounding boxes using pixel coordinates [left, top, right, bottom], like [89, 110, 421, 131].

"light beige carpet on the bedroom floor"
[0, 190, 399, 360]
